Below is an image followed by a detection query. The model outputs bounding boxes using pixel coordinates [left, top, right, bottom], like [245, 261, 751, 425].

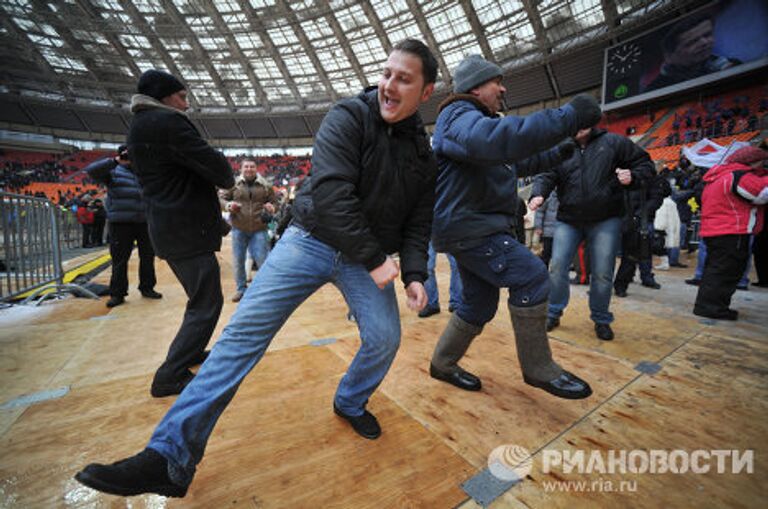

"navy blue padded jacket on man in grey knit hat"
[432, 94, 577, 252]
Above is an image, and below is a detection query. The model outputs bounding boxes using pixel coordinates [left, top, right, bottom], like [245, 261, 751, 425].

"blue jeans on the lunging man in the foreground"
[148, 226, 400, 485]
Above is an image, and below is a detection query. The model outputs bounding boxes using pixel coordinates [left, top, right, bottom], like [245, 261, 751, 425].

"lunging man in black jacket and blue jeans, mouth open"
[76, 39, 437, 497]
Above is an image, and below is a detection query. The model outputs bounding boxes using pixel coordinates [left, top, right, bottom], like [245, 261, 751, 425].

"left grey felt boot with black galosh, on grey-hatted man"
[429, 313, 483, 391]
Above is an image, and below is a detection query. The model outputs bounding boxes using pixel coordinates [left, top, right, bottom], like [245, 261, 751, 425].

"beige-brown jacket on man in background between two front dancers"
[219, 175, 276, 233]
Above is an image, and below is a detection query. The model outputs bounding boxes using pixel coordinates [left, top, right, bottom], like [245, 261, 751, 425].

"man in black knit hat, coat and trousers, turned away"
[128, 70, 235, 397]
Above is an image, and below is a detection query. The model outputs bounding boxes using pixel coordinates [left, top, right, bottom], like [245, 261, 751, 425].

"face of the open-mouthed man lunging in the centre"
[379, 50, 435, 124]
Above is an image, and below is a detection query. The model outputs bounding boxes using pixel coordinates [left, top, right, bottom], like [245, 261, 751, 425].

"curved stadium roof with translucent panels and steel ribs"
[0, 0, 700, 146]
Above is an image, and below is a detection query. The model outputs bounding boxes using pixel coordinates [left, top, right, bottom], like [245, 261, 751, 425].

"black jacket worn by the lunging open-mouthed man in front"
[292, 87, 437, 285]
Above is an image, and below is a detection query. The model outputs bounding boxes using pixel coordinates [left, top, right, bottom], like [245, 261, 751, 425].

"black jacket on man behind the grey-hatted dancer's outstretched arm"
[531, 129, 656, 224]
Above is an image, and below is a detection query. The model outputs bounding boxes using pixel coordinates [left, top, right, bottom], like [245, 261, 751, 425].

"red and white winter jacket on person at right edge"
[700, 163, 768, 237]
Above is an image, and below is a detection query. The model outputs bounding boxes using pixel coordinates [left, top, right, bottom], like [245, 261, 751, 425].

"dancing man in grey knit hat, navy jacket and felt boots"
[430, 55, 601, 399]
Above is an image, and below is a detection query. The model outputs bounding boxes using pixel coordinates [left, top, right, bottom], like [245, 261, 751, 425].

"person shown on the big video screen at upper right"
[646, 15, 741, 90]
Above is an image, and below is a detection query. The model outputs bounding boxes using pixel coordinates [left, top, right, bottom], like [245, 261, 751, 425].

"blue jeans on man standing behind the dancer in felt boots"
[548, 217, 621, 323]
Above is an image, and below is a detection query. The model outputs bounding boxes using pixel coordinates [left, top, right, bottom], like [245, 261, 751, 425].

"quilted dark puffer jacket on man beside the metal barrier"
[85, 157, 147, 223]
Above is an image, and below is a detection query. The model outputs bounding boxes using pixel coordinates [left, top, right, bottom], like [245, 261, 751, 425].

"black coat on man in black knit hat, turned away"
[128, 95, 235, 259]
